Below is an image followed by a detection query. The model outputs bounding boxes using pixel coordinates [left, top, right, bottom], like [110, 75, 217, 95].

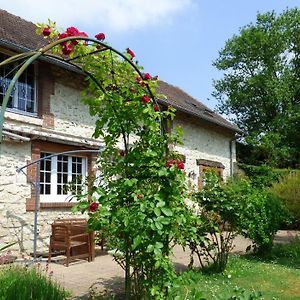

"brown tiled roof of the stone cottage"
[0, 9, 240, 132]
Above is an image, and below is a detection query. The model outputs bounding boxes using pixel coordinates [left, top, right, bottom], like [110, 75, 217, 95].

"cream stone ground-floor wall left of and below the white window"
[0, 142, 85, 254]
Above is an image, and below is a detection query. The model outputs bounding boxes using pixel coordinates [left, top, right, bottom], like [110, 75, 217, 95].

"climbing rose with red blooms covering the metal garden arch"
[37, 21, 195, 299]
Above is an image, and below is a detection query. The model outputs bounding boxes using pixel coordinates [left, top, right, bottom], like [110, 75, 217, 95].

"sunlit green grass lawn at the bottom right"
[174, 248, 300, 300]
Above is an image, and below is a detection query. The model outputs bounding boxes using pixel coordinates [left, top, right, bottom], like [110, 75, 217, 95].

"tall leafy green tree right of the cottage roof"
[213, 8, 300, 166]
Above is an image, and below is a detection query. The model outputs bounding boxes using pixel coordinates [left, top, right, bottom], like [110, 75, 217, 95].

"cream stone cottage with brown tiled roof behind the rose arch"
[0, 10, 238, 252]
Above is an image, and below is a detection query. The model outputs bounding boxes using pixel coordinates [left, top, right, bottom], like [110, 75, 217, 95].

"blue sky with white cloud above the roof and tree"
[0, 0, 300, 109]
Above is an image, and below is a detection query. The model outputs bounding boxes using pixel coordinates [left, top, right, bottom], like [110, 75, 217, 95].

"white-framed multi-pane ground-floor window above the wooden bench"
[40, 153, 87, 202]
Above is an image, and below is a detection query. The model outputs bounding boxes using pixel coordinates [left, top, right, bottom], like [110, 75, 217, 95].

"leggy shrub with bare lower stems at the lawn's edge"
[188, 172, 240, 272]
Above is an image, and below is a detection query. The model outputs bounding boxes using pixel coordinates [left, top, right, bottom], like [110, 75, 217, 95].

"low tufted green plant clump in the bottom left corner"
[0, 266, 70, 300]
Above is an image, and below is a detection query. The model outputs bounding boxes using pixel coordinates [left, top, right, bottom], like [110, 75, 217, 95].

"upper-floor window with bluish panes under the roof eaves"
[0, 53, 37, 114]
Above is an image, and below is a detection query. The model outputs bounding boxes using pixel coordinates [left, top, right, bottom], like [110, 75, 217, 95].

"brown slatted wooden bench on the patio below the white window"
[48, 218, 95, 267]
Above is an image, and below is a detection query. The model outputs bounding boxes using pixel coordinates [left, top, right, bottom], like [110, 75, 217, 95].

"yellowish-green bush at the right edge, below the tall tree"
[270, 171, 300, 227]
